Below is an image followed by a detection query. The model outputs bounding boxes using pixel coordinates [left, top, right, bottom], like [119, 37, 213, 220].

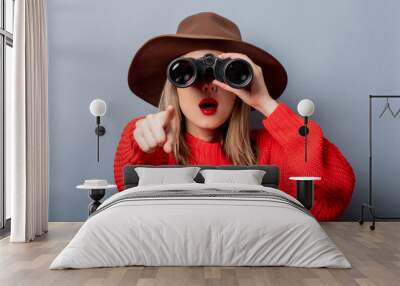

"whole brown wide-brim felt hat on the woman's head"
[128, 12, 287, 106]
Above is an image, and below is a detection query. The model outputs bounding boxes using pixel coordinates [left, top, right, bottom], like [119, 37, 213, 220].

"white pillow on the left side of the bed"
[135, 167, 200, 186]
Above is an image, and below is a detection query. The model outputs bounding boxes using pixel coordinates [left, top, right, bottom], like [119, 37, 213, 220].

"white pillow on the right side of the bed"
[200, 169, 265, 185]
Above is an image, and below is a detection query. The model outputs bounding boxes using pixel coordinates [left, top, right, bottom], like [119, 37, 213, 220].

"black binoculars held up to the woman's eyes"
[167, 54, 253, 88]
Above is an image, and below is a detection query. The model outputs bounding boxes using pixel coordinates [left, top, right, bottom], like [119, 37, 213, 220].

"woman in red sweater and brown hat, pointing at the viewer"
[114, 13, 355, 220]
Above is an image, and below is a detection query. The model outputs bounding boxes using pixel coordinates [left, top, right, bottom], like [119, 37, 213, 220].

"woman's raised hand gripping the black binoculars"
[213, 53, 278, 116]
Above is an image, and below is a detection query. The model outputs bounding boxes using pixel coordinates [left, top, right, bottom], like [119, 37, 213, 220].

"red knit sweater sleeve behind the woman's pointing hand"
[114, 116, 166, 192]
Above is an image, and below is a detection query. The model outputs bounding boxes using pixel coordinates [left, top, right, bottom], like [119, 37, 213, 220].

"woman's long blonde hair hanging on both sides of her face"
[159, 80, 257, 165]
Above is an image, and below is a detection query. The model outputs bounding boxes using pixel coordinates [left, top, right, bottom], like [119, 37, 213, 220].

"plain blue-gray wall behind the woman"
[47, 0, 400, 221]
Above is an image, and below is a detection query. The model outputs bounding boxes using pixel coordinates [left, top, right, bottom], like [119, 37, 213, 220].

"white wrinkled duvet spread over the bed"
[50, 183, 351, 269]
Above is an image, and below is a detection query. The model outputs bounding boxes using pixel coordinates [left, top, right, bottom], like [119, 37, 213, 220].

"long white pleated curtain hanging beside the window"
[6, 0, 49, 242]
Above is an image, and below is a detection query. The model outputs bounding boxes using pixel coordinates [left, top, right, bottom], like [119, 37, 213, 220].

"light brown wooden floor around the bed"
[0, 222, 400, 286]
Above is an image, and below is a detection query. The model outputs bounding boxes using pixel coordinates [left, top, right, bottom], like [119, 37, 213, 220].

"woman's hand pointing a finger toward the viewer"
[133, 105, 175, 153]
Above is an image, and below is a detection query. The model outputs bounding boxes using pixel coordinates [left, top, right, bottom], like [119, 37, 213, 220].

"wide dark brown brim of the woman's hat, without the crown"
[128, 34, 287, 106]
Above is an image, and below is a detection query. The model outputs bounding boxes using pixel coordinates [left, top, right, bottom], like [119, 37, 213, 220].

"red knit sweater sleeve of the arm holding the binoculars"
[263, 102, 355, 220]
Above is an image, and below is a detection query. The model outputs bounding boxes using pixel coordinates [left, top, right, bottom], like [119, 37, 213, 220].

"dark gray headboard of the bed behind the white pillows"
[124, 165, 279, 189]
